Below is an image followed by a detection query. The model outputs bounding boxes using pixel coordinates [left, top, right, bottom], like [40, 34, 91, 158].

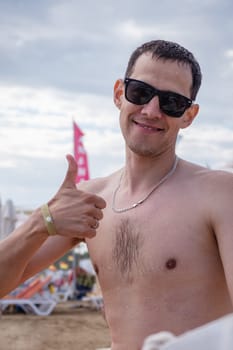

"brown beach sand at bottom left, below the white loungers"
[0, 302, 110, 350]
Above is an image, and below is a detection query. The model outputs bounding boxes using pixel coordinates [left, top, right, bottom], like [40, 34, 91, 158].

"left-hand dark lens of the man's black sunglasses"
[125, 80, 154, 105]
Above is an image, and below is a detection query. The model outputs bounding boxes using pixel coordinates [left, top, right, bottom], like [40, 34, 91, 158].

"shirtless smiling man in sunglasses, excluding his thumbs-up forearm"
[2, 41, 233, 350]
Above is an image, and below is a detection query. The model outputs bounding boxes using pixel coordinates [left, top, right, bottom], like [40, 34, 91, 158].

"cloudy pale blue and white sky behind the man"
[0, 0, 233, 209]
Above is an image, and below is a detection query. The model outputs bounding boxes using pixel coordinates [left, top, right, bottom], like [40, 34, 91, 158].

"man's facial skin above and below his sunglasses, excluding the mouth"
[120, 54, 192, 158]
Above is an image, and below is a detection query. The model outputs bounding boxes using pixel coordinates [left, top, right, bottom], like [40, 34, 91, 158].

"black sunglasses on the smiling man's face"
[124, 78, 192, 118]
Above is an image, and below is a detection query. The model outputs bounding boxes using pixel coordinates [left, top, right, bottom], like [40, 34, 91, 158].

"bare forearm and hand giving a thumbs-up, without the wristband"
[0, 156, 105, 297]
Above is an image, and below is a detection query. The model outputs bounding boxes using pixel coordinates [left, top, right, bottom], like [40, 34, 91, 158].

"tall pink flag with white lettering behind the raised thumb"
[73, 122, 89, 183]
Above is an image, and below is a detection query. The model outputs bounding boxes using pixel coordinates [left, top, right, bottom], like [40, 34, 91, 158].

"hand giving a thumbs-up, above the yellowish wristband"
[48, 155, 106, 239]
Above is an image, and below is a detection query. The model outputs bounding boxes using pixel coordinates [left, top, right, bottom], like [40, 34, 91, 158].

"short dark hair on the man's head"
[125, 40, 202, 100]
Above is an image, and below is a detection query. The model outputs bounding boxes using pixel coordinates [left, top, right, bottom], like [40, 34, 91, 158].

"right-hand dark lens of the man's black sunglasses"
[159, 92, 189, 118]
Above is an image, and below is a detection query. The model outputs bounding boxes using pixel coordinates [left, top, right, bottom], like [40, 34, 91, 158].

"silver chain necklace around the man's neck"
[112, 157, 179, 213]
